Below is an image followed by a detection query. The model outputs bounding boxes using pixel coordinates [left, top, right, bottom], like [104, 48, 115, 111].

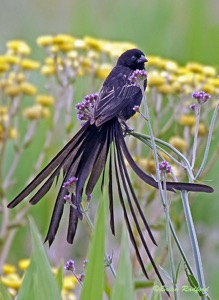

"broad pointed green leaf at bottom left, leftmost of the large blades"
[18, 218, 61, 300]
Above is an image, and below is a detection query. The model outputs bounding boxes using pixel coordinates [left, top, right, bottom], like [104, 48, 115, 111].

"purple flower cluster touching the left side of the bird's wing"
[75, 93, 98, 121]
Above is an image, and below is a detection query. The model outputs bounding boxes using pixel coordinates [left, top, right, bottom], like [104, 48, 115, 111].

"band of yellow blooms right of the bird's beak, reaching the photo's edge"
[147, 56, 219, 95]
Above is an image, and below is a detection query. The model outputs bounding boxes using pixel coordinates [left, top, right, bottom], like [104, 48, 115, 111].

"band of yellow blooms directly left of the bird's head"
[37, 34, 136, 80]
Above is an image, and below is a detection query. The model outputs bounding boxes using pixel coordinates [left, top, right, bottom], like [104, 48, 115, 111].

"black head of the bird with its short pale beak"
[117, 49, 148, 70]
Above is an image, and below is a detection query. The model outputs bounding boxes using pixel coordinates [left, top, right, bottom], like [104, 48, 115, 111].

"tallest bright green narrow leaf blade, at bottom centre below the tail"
[80, 197, 106, 300]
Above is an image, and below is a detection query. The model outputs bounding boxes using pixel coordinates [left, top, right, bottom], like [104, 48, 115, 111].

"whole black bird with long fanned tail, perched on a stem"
[8, 49, 213, 284]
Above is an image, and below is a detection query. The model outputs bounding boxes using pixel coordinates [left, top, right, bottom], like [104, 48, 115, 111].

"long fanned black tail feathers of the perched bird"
[8, 118, 213, 288]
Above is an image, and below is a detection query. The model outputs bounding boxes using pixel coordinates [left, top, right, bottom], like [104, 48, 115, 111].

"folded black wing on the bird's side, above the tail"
[94, 66, 141, 126]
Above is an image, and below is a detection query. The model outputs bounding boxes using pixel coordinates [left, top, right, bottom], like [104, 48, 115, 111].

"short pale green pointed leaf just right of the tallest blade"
[111, 228, 134, 300]
